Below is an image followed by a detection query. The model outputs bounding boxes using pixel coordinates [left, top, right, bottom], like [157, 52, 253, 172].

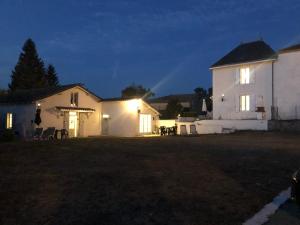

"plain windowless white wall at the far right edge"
[274, 51, 300, 120]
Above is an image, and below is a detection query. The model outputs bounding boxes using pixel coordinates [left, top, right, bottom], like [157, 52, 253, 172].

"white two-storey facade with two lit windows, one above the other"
[212, 62, 272, 120]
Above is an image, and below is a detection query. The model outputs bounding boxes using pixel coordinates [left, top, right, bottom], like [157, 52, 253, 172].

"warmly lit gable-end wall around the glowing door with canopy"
[37, 87, 101, 137]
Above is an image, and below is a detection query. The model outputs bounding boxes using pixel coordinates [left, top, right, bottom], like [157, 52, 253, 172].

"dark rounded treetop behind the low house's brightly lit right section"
[122, 83, 154, 99]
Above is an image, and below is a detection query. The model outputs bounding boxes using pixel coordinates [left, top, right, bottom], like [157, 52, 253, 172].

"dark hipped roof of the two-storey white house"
[211, 40, 277, 68]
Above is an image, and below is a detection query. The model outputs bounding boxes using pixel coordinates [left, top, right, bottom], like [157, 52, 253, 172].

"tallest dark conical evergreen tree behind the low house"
[9, 39, 47, 91]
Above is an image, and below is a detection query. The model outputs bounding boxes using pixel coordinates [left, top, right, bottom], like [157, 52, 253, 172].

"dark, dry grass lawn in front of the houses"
[0, 132, 300, 225]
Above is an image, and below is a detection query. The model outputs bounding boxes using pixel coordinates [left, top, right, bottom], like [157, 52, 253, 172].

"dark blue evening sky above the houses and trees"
[0, 0, 300, 97]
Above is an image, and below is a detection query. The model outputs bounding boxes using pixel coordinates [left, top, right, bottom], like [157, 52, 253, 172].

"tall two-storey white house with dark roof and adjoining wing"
[202, 40, 300, 130]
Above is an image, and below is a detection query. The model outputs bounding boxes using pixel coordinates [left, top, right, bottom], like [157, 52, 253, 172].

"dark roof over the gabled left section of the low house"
[0, 84, 101, 103]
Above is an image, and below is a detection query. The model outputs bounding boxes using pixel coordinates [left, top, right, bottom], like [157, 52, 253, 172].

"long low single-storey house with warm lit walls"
[0, 84, 159, 137]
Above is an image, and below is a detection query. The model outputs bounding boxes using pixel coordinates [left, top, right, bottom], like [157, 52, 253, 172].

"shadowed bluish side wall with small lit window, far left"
[0, 104, 36, 137]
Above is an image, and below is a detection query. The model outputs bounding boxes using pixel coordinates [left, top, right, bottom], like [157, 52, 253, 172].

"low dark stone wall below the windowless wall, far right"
[268, 120, 300, 132]
